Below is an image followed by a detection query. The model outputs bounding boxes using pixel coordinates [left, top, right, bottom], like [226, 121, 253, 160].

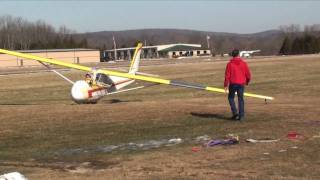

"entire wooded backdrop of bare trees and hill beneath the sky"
[0, 15, 320, 55]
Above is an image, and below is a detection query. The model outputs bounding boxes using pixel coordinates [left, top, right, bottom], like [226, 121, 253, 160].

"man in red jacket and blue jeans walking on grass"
[224, 49, 251, 120]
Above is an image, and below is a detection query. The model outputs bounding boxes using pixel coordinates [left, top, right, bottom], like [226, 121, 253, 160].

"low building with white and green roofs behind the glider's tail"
[103, 43, 211, 61]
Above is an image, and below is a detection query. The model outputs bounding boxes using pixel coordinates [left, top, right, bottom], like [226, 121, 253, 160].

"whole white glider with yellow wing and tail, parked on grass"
[0, 43, 273, 104]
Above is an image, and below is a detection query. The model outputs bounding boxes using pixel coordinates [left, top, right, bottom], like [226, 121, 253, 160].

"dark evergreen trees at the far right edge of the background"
[279, 25, 320, 55]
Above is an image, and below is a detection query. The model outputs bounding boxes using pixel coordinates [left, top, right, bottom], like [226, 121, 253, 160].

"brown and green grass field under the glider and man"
[0, 55, 320, 179]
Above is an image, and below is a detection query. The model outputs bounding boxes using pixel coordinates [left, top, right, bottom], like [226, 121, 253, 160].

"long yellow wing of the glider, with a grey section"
[0, 49, 274, 100]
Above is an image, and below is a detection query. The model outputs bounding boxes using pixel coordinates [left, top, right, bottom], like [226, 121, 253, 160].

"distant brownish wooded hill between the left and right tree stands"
[74, 29, 284, 55]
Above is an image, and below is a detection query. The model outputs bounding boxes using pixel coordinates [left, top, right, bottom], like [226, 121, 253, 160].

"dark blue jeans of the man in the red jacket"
[228, 84, 244, 117]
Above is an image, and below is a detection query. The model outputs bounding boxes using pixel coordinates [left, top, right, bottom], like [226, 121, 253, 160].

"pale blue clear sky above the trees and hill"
[0, 0, 320, 33]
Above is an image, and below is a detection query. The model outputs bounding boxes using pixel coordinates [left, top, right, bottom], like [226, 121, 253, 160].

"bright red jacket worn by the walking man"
[224, 57, 251, 87]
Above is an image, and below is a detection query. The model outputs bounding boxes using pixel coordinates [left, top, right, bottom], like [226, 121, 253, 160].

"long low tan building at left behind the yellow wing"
[0, 48, 100, 67]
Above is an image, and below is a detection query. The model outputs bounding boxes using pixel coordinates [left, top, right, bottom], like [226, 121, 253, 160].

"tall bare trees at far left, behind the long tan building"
[0, 15, 88, 50]
